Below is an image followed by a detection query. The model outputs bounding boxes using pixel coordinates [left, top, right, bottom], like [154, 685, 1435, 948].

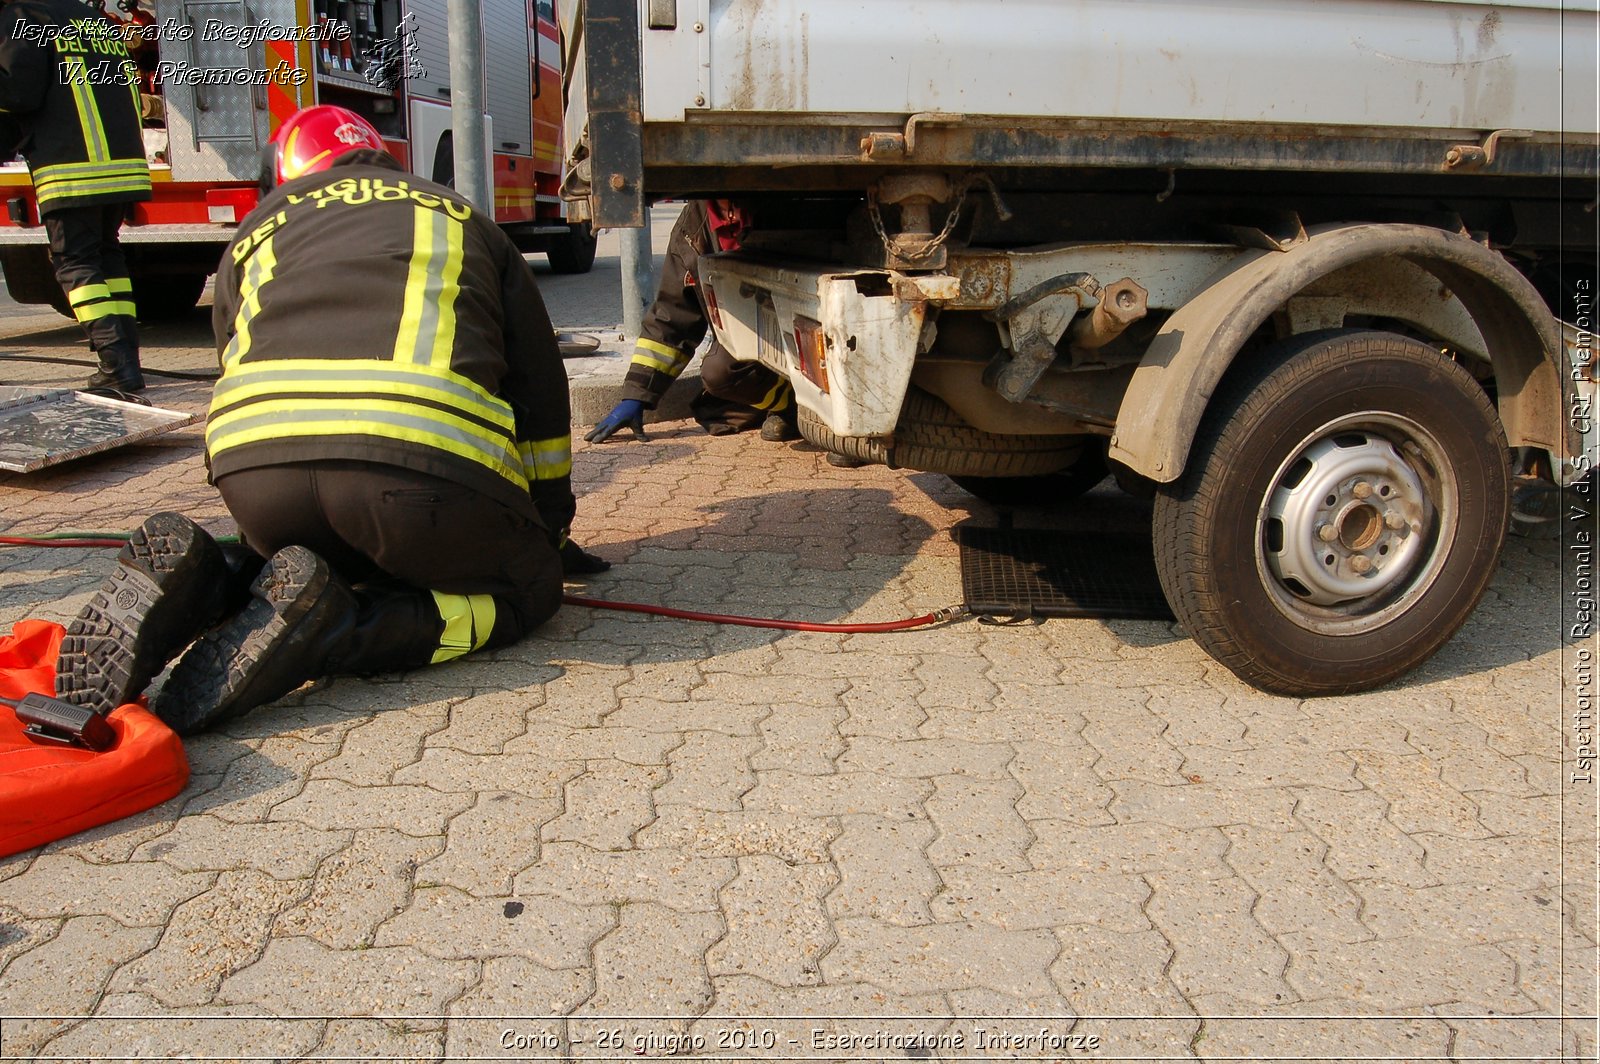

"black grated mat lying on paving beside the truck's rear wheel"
[952, 525, 1173, 621]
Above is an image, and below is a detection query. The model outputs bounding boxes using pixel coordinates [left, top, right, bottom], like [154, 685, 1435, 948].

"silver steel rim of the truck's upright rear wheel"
[1256, 411, 1461, 635]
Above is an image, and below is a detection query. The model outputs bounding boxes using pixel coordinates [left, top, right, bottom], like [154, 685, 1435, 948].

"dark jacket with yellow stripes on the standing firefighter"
[0, 0, 150, 214]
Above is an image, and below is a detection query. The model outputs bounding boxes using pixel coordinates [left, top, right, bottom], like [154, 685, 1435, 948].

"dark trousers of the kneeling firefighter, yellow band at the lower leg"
[216, 459, 562, 674]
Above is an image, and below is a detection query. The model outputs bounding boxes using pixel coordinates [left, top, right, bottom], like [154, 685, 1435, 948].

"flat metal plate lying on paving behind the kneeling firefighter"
[0, 386, 205, 474]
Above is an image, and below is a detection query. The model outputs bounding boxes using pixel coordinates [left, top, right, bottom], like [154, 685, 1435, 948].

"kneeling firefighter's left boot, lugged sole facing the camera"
[56, 514, 227, 714]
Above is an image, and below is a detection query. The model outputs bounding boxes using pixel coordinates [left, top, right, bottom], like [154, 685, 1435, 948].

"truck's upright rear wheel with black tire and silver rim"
[1154, 331, 1509, 696]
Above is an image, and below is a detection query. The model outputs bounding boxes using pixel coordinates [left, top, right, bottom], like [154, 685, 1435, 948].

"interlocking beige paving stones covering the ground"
[0, 246, 1597, 1061]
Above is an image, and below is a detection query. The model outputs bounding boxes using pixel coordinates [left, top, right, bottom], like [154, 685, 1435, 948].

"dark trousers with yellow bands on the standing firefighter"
[45, 203, 139, 378]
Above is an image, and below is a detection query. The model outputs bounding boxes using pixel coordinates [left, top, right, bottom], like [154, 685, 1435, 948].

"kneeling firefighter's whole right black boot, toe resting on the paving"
[150, 547, 355, 734]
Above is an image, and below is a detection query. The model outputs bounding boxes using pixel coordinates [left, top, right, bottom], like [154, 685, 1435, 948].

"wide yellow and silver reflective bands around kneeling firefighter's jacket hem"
[206, 358, 528, 490]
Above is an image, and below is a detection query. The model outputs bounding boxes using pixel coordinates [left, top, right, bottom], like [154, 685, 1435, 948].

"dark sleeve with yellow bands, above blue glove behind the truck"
[622, 200, 712, 410]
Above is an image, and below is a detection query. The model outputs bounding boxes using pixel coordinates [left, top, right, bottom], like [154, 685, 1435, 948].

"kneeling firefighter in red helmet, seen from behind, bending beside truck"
[56, 106, 608, 734]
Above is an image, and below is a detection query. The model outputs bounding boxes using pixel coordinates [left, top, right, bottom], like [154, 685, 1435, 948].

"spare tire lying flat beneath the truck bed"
[798, 387, 1083, 477]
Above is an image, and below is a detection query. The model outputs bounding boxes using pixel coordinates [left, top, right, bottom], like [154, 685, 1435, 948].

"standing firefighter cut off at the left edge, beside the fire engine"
[0, 0, 150, 392]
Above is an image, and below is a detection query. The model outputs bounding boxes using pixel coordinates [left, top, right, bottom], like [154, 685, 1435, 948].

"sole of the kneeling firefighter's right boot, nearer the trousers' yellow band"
[154, 547, 328, 734]
